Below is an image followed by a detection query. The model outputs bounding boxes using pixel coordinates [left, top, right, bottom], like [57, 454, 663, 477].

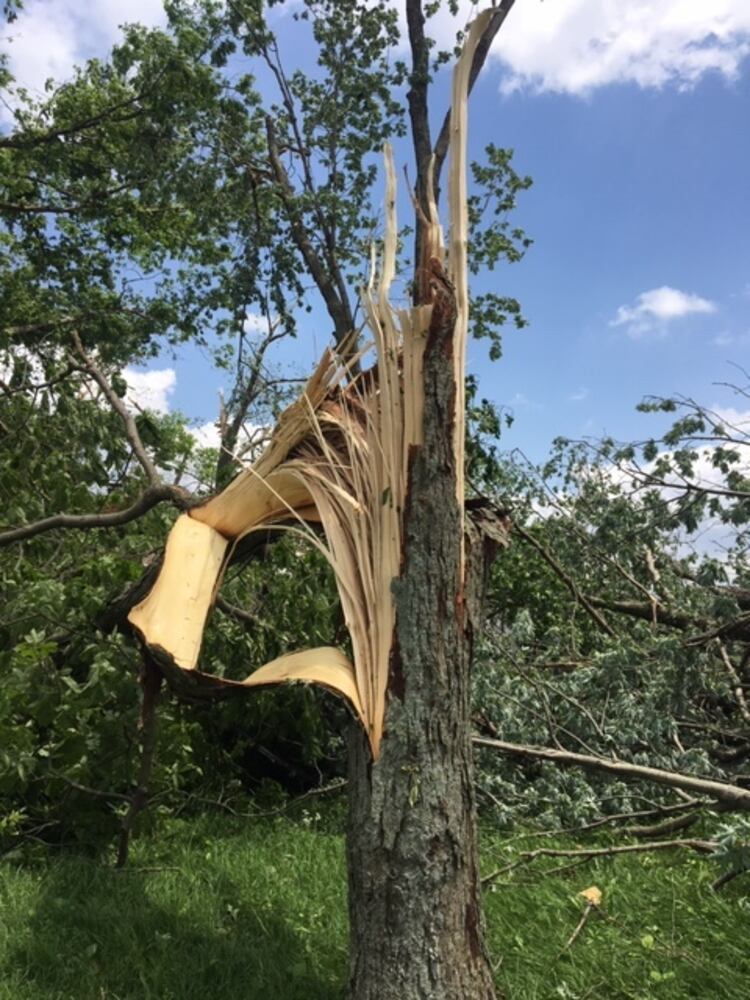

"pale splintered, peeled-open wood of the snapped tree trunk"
[129, 10, 492, 759]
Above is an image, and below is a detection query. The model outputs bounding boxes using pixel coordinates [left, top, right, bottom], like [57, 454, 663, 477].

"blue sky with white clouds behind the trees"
[1, 0, 750, 459]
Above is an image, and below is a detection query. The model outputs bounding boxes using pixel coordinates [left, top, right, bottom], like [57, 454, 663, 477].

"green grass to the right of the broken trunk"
[484, 838, 750, 1000]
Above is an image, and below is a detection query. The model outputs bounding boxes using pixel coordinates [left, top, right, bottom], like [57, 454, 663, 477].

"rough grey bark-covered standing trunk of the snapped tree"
[347, 279, 495, 1000]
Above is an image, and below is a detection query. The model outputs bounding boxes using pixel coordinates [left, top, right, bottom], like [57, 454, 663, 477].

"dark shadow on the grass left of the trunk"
[5, 858, 345, 1000]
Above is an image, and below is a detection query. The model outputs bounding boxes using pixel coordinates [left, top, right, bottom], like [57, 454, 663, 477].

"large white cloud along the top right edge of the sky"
[493, 0, 750, 94]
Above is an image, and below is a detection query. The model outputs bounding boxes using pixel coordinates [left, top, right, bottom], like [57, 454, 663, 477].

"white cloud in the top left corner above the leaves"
[0, 0, 166, 122]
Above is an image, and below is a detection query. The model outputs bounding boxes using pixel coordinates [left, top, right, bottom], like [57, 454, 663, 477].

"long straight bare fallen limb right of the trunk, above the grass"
[473, 736, 750, 811]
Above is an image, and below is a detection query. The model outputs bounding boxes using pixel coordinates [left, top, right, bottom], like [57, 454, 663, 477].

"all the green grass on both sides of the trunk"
[0, 814, 750, 1000]
